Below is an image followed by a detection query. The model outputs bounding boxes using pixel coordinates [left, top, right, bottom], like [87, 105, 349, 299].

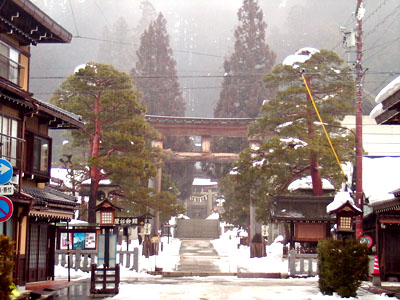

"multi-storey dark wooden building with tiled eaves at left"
[0, 0, 83, 284]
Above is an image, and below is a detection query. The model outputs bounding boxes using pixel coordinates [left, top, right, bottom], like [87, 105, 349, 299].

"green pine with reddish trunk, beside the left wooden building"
[51, 63, 166, 223]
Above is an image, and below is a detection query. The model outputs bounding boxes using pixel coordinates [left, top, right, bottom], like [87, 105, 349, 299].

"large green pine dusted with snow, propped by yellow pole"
[252, 48, 355, 195]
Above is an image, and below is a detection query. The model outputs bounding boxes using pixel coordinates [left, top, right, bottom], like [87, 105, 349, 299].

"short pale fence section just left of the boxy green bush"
[288, 250, 318, 277]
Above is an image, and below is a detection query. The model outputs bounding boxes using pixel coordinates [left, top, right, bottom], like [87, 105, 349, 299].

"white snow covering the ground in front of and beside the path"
[55, 229, 396, 300]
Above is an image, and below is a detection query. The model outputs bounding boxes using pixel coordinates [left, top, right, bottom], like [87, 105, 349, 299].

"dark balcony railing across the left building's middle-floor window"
[0, 133, 25, 169]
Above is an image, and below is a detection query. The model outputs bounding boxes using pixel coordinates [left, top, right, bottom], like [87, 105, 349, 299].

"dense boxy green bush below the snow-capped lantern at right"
[318, 239, 368, 297]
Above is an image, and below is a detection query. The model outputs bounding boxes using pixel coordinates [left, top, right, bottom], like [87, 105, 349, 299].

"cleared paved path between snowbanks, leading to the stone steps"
[178, 240, 221, 273]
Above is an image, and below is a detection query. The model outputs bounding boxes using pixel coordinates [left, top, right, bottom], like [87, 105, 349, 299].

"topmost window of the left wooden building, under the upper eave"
[0, 42, 20, 84]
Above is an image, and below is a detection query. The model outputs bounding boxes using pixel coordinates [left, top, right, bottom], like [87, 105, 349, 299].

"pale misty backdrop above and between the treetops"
[30, 0, 400, 117]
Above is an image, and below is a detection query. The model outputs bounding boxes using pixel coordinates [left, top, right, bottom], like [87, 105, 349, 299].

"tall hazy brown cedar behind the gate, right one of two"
[203, 0, 276, 178]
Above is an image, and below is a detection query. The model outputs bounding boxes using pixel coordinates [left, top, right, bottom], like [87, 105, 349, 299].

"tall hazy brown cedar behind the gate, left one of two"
[131, 13, 194, 202]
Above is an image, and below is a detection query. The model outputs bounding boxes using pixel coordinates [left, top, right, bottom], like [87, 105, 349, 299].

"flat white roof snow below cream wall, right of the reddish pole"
[363, 157, 400, 203]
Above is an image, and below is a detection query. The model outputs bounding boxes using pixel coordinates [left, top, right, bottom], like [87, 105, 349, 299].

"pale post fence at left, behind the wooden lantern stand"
[55, 248, 139, 272]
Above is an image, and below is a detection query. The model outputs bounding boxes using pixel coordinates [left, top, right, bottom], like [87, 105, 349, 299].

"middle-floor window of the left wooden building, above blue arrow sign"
[0, 114, 20, 166]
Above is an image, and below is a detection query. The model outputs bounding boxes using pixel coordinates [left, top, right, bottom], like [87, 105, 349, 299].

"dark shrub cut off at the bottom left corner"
[0, 234, 15, 299]
